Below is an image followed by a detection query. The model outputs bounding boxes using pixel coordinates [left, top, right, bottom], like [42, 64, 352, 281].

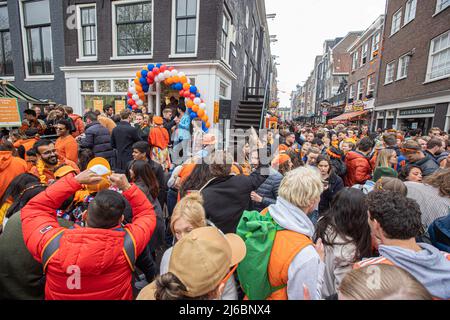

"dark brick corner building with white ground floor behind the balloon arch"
[61, 0, 272, 132]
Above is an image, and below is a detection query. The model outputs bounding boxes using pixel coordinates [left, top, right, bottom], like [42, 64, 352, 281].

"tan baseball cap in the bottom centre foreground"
[138, 227, 247, 300]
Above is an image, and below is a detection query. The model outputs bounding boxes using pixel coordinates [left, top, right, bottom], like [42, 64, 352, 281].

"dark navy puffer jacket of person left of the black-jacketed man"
[80, 121, 114, 163]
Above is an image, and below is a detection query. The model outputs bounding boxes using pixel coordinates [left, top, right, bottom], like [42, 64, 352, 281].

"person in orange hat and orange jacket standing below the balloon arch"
[148, 117, 171, 171]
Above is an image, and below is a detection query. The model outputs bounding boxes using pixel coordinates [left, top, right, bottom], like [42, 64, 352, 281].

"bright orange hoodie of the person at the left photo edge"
[0, 151, 28, 198]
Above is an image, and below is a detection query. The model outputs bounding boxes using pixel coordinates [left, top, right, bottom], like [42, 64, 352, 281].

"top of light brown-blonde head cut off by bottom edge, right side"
[339, 264, 432, 300]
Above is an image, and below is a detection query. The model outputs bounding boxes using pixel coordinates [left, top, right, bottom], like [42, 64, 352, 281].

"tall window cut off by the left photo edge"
[0, 4, 14, 76]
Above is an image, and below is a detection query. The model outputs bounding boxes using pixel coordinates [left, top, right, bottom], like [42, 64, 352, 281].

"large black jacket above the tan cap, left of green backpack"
[202, 173, 261, 234]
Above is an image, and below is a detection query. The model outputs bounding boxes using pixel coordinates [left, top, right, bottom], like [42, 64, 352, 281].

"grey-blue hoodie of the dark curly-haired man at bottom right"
[379, 243, 450, 299]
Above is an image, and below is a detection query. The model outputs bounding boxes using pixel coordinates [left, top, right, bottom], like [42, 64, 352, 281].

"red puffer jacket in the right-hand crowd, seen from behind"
[344, 151, 372, 187]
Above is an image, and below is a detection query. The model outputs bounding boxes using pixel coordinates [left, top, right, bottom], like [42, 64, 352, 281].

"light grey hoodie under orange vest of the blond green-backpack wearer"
[269, 197, 325, 300]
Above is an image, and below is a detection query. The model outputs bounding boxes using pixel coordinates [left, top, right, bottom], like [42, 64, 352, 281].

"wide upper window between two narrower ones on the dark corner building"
[113, 1, 153, 57]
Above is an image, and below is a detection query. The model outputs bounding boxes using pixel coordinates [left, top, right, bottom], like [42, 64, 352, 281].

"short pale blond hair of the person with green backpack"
[278, 166, 323, 210]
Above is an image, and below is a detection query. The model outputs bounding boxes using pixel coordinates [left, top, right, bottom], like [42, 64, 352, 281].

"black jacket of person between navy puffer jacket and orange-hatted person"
[111, 121, 141, 172]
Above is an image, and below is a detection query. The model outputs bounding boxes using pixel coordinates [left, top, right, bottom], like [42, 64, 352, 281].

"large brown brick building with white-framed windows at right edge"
[375, 0, 450, 133]
